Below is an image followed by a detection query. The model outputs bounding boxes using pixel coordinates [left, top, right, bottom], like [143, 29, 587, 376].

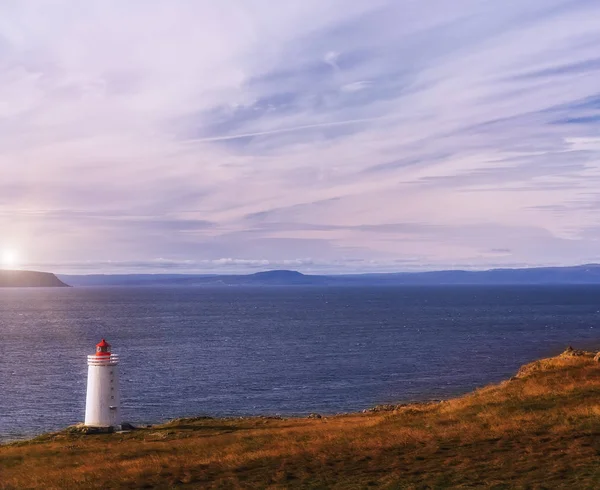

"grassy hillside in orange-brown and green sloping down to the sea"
[0, 346, 600, 489]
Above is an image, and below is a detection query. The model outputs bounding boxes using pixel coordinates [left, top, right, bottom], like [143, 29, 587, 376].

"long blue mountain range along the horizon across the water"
[59, 264, 600, 287]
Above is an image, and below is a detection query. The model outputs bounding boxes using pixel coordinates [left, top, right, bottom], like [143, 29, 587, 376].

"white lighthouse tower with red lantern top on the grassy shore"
[85, 339, 121, 428]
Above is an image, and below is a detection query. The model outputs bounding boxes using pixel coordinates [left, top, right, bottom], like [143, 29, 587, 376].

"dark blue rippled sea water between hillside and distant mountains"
[0, 286, 600, 440]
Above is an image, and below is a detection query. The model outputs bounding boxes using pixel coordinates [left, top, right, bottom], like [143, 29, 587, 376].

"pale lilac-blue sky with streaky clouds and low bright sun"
[0, 0, 600, 273]
